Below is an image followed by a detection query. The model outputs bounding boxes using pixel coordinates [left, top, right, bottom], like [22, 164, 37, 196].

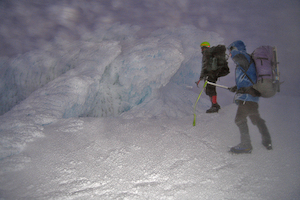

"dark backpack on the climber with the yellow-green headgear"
[206, 45, 230, 77]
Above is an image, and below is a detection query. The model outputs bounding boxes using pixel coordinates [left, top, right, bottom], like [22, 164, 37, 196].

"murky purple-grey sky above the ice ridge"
[0, 0, 300, 97]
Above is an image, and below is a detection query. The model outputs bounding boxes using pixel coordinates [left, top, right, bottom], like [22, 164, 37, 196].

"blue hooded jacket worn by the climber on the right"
[227, 40, 259, 102]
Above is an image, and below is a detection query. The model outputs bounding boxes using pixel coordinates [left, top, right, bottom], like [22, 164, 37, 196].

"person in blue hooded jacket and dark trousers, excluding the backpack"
[227, 40, 272, 153]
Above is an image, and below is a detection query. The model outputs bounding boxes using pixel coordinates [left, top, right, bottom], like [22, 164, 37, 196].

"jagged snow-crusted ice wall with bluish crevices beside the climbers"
[0, 23, 223, 159]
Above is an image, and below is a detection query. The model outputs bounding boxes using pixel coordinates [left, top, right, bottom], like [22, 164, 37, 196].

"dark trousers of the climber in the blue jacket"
[235, 101, 271, 146]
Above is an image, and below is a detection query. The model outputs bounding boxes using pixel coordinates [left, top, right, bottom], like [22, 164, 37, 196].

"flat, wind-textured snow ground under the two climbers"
[0, 91, 300, 200]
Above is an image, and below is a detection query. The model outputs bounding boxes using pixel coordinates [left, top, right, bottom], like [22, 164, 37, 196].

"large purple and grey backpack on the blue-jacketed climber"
[251, 46, 280, 98]
